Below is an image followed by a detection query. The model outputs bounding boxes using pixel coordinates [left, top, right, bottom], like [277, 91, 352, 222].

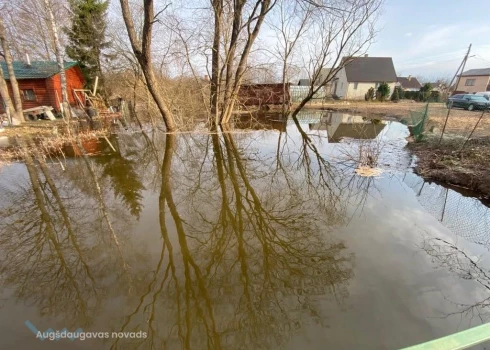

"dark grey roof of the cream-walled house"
[344, 57, 396, 83]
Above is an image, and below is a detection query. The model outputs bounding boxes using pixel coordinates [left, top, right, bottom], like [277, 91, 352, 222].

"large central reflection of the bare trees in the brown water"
[113, 132, 352, 348]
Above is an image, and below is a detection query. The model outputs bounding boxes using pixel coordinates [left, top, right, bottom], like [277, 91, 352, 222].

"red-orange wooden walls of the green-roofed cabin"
[0, 66, 85, 113]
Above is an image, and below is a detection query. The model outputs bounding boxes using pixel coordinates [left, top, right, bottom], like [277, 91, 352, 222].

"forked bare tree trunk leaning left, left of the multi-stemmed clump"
[120, 0, 176, 131]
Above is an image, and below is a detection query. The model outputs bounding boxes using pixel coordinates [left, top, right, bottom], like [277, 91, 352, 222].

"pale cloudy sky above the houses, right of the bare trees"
[369, 0, 490, 79]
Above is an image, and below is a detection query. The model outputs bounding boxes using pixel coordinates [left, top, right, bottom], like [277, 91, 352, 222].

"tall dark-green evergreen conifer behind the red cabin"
[66, 0, 109, 91]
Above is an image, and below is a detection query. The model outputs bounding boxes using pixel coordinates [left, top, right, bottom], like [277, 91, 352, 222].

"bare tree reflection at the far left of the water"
[0, 141, 140, 326]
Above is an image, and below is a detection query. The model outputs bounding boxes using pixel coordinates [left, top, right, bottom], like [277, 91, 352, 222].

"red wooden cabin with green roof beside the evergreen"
[0, 61, 85, 113]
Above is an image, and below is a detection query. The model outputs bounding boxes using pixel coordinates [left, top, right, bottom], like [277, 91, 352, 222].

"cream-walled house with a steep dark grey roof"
[331, 55, 397, 100]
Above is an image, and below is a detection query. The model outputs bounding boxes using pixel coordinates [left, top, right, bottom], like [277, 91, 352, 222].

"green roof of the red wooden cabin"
[0, 61, 77, 80]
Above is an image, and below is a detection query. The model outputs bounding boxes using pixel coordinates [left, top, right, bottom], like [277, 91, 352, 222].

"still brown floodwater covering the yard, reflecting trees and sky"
[0, 113, 490, 349]
